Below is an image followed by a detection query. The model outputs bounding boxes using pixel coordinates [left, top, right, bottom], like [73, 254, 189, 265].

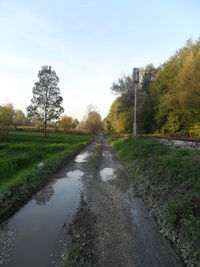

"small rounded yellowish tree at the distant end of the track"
[85, 105, 102, 134]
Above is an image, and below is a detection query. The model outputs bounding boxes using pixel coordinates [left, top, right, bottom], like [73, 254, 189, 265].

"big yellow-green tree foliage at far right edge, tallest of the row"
[151, 41, 200, 134]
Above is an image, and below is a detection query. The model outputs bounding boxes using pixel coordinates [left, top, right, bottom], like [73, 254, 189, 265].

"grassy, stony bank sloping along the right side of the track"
[110, 136, 200, 266]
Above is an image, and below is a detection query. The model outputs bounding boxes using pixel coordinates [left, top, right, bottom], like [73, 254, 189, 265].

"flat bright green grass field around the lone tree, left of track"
[0, 132, 92, 193]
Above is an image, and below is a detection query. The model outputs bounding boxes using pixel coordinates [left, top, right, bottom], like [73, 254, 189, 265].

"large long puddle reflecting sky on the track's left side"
[0, 170, 84, 267]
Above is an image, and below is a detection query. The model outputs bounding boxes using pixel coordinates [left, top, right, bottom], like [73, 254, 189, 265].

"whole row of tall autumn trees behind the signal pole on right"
[104, 39, 200, 136]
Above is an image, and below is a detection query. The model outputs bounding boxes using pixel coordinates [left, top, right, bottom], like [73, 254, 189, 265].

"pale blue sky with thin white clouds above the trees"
[0, 0, 200, 120]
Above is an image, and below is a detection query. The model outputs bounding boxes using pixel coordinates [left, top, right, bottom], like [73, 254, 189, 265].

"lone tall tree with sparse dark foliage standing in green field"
[27, 66, 64, 136]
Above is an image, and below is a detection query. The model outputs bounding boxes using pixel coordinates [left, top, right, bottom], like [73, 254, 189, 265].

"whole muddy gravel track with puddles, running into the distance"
[0, 138, 181, 267]
